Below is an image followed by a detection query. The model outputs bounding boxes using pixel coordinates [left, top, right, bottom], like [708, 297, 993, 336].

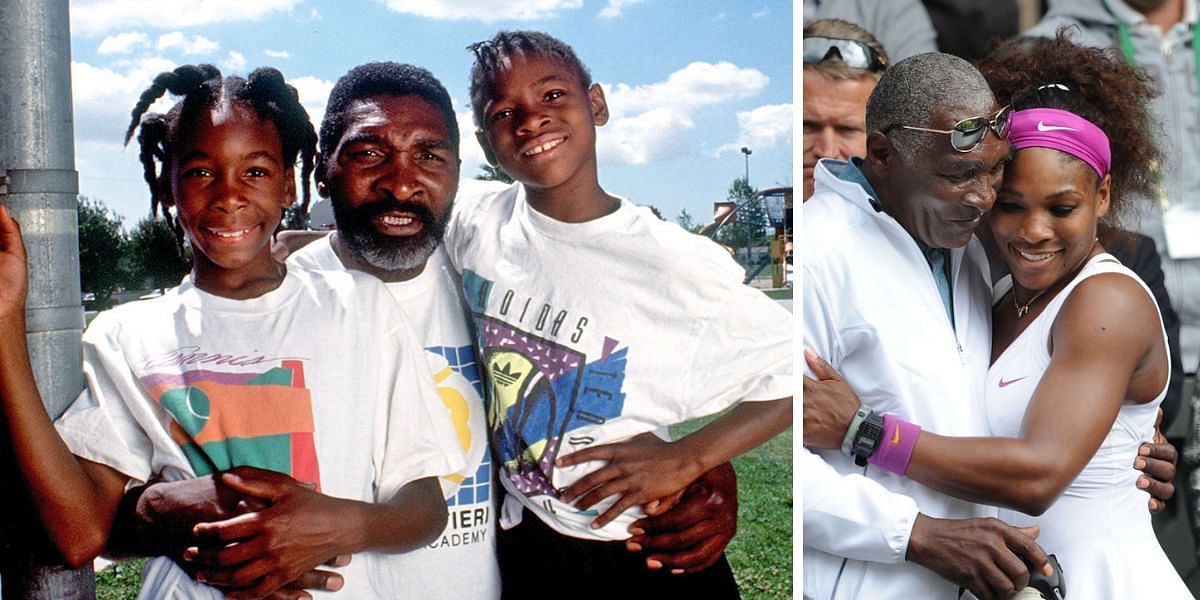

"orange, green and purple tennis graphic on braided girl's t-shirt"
[140, 360, 320, 491]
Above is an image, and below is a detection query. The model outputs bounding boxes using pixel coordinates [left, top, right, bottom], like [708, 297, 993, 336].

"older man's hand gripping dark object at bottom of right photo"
[905, 515, 1050, 600]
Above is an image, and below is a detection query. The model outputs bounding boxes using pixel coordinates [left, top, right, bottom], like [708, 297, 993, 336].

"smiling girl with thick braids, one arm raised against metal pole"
[0, 65, 461, 598]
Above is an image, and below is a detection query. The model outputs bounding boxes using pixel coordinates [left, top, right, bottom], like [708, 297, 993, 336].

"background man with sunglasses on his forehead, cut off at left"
[804, 19, 888, 200]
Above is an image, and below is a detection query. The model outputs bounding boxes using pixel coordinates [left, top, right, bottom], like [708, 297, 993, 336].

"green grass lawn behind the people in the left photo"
[96, 421, 792, 600]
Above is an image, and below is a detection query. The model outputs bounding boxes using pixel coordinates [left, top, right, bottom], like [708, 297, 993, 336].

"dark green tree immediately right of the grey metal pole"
[78, 196, 126, 307]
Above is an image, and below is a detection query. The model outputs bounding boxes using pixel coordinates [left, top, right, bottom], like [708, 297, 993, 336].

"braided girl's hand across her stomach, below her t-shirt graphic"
[184, 467, 353, 598]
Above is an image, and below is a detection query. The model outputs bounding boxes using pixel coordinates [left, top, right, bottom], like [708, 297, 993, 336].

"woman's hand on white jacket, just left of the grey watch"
[804, 348, 862, 450]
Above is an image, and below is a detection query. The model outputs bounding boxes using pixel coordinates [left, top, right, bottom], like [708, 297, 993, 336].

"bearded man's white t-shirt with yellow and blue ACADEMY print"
[288, 235, 500, 600]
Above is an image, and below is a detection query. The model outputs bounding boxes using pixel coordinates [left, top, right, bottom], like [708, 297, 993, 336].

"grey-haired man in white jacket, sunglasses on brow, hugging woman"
[800, 54, 1046, 600]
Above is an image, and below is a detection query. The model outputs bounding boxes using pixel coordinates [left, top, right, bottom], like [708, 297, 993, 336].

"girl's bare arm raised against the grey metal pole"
[0, 205, 126, 568]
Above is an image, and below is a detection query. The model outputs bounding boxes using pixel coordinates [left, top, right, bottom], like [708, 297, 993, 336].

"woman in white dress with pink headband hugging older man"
[804, 35, 1192, 600]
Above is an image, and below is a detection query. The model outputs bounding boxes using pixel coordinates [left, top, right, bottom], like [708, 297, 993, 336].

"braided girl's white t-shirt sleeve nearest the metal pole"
[54, 328, 156, 482]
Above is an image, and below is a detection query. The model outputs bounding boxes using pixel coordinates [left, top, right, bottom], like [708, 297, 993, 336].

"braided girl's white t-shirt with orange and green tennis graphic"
[56, 269, 463, 599]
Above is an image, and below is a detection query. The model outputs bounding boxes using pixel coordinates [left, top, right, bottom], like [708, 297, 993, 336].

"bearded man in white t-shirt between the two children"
[114, 62, 737, 599]
